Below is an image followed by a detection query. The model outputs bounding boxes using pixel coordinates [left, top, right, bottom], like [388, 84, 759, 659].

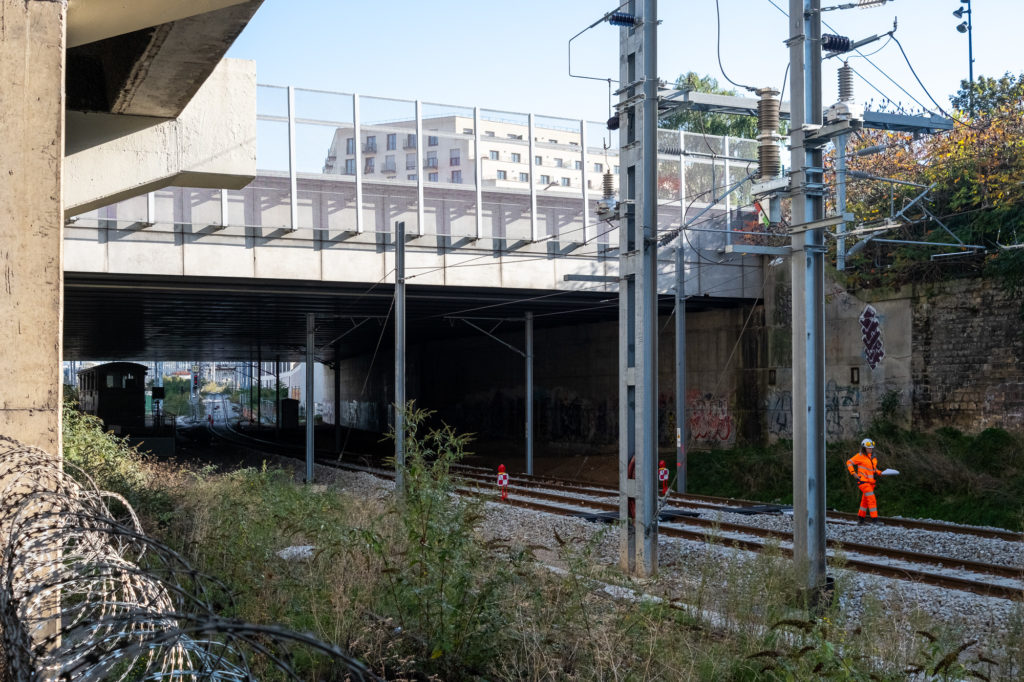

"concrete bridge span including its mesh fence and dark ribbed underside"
[63, 86, 772, 359]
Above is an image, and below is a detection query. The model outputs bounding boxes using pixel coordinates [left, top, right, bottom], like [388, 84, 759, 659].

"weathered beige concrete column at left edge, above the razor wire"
[0, 0, 68, 453]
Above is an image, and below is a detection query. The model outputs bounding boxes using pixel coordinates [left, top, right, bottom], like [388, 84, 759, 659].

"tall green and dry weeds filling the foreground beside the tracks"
[59, 401, 1024, 682]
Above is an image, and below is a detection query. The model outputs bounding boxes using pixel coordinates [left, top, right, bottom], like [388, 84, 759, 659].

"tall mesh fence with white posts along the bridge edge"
[66, 85, 779, 298]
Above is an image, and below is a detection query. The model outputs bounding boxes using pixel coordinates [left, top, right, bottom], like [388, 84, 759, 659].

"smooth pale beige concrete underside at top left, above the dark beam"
[68, 0, 256, 48]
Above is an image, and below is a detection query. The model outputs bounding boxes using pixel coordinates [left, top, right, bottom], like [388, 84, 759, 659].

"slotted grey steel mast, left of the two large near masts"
[618, 0, 657, 577]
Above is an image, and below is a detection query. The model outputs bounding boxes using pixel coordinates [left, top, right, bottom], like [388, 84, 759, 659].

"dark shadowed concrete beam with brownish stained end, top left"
[67, 0, 263, 118]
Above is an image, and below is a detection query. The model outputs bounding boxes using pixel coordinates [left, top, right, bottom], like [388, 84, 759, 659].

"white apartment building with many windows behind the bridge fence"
[323, 116, 618, 199]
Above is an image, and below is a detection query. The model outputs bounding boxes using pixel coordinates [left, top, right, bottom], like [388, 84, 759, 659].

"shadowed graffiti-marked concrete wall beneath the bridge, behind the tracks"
[328, 306, 763, 456]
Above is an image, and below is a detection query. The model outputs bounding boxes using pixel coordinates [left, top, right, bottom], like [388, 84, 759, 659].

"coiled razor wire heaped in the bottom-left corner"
[0, 435, 380, 682]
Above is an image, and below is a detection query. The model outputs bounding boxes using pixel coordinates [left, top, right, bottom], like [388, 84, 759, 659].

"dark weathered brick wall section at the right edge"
[911, 280, 1024, 433]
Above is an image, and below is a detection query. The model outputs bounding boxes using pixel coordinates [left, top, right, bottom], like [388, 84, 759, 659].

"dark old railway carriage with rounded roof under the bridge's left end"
[78, 363, 148, 434]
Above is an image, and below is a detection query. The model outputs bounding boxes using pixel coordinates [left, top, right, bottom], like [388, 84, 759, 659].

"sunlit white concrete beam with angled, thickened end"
[65, 59, 256, 215]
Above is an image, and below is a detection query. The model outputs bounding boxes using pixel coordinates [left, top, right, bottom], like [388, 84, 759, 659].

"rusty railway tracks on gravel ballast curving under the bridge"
[207, 426, 1024, 600]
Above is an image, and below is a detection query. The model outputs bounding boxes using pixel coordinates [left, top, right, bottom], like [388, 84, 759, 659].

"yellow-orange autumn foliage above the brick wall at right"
[831, 74, 1024, 291]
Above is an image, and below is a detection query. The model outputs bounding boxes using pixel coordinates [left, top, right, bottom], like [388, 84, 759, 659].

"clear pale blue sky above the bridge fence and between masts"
[228, 0, 1024, 121]
